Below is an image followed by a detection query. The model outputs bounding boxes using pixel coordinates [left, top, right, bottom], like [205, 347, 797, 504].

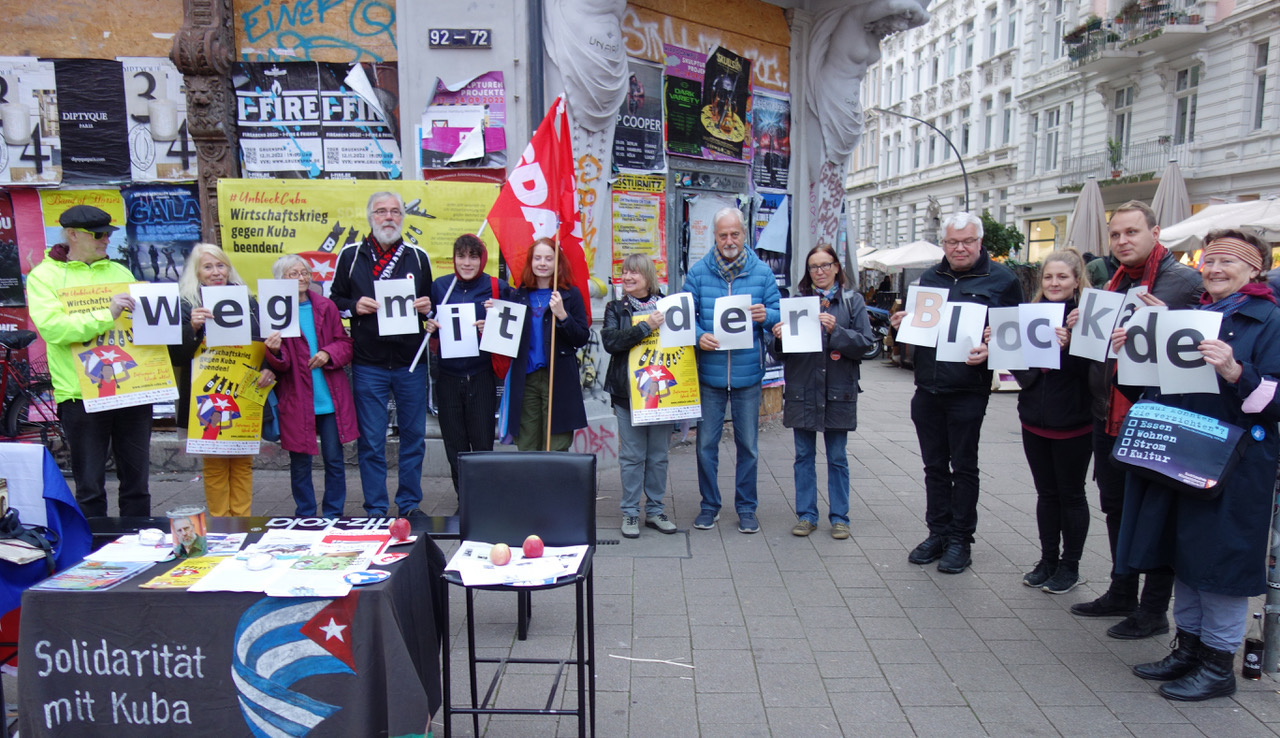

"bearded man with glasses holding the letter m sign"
[329, 192, 431, 517]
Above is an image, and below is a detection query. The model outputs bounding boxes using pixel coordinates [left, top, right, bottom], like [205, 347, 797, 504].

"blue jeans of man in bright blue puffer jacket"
[698, 384, 760, 514]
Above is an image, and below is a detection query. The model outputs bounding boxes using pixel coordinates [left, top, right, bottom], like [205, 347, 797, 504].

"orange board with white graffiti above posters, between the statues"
[622, 4, 790, 92]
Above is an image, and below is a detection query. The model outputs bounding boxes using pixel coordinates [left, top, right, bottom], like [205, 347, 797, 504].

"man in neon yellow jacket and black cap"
[27, 205, 151, 518]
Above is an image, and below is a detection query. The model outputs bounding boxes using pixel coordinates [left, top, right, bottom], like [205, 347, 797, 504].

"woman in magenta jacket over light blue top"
[266, 255, 360, 517]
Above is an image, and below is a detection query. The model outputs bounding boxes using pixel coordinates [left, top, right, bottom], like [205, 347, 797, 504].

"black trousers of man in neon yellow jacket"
[58, 400, 151, 518]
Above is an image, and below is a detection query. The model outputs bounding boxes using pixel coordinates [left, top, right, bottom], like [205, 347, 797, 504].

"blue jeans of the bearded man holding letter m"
[352, 365, 426, 515]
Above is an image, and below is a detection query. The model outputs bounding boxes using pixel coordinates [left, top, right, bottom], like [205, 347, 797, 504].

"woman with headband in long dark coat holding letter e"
[1112, 230, 1280, 702]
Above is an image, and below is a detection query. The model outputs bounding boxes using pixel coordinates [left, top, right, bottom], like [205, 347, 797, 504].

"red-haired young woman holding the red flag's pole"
[504, 238, 591, 451]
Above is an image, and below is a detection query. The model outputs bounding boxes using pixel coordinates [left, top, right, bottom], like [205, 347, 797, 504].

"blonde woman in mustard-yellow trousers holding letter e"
[169, 243, 273, 517]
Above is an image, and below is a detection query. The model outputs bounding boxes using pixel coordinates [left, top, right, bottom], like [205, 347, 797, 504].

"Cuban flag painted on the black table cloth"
[232, 592, 358, 738]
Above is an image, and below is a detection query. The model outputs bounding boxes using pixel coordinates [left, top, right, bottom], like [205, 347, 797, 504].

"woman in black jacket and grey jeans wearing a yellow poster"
[600, 253, 676, 538]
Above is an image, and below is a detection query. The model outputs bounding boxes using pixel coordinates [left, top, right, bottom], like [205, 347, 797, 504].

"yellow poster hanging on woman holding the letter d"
[627, 316, 703, 426]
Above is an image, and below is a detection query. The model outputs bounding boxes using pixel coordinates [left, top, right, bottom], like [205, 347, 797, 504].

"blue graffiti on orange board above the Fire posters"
[234, 0, 396, 61]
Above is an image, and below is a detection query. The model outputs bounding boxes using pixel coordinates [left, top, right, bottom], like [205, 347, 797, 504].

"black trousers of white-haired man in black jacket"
[911, 389, 991, 544]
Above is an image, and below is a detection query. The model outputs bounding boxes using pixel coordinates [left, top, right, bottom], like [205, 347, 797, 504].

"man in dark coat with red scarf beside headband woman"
[1068, 201, 1203, 641]
